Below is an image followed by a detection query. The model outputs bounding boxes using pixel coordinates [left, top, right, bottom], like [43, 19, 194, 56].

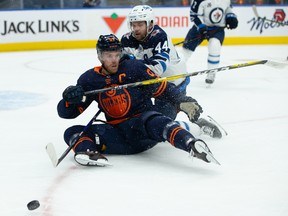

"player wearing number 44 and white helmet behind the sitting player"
[121, 5, 222, 138]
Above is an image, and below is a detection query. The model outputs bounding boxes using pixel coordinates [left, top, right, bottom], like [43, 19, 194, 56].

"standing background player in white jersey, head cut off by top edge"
[183, 0, 238, 84]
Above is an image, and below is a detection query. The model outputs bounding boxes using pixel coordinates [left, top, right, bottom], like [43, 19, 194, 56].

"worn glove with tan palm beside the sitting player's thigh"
[179, 97, 203, 123]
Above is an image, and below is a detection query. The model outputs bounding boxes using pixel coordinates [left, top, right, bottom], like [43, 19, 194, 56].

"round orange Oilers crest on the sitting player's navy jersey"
[99, 85, 131, 118]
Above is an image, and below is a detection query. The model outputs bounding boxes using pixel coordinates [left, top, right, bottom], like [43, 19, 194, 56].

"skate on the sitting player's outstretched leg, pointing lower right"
[190, 139, 220, 165]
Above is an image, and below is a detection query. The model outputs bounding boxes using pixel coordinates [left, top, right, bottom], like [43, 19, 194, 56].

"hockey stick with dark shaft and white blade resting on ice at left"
[46, 110, 101, 167]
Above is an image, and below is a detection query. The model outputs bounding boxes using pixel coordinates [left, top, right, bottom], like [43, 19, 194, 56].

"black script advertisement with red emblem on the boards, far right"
[247, 9, 288, 34]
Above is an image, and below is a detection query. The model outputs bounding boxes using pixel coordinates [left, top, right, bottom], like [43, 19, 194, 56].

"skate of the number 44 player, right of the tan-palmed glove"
[196, 117, 222, 139]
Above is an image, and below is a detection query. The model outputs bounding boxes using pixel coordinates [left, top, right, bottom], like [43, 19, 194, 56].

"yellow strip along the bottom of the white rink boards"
[0, 36, 288, 52]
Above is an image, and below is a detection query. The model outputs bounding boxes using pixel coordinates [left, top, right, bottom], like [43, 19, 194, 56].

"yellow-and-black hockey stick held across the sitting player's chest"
[85, 60, 288, 95]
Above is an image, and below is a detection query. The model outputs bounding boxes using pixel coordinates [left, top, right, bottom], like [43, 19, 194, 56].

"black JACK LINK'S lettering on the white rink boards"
[0, 20, 80, 36]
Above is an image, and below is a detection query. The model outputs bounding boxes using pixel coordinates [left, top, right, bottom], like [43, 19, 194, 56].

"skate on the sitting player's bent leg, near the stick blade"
[74, 151, 111, 167]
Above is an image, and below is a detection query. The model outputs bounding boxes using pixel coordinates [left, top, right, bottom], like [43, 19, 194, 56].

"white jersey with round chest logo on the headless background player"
[190, 0, 233, 27]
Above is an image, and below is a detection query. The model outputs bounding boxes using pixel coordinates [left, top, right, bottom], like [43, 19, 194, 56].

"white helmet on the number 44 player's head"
[128, 5, 155, 33]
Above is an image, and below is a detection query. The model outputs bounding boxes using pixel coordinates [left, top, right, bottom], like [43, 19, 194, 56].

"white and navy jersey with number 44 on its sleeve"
[121, 25, 187, 85]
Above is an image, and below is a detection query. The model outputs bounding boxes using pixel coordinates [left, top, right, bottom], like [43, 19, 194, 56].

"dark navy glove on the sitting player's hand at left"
[62, 86, 85, 104]
